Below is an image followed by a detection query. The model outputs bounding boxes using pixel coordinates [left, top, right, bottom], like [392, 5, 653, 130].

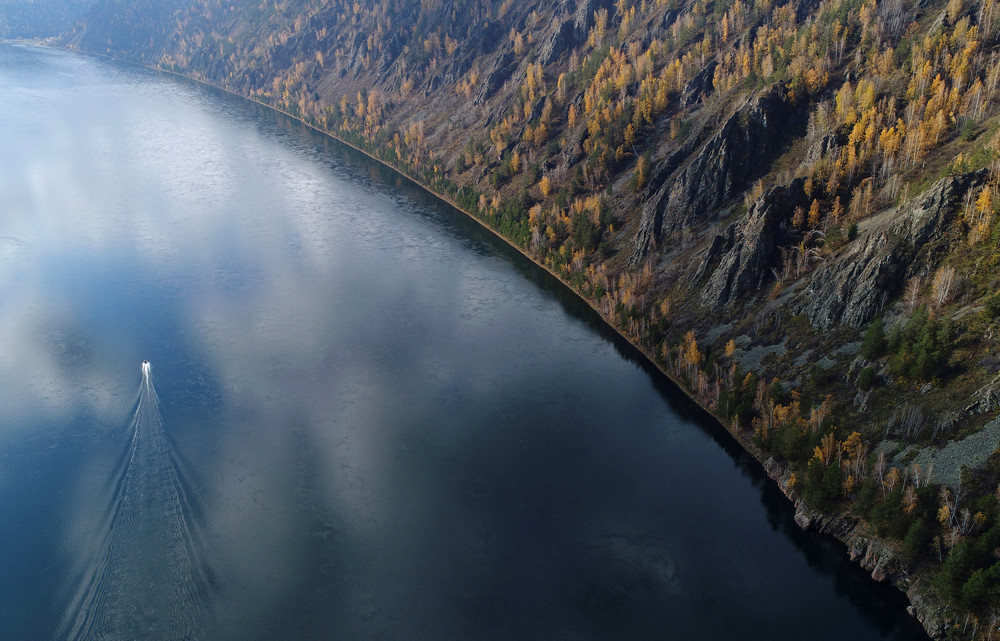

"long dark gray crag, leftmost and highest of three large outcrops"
[636, 89, 792, 256]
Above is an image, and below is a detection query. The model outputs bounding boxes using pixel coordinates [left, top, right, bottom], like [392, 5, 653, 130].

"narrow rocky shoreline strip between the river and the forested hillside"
[41, 40, 949, 638]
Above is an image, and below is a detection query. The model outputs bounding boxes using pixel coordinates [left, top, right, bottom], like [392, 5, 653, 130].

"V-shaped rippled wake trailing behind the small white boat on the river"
[58, 361, 210, 641]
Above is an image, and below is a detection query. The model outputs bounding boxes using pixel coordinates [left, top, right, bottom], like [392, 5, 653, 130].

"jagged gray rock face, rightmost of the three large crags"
[794, 172, 986, 328]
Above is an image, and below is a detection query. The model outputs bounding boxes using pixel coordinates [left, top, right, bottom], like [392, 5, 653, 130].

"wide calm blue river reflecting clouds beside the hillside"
[0, 46, 920, 641]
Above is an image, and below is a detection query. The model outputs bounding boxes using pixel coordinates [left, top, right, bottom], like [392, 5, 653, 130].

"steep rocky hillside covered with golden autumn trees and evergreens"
[35, 0, 1000, 638]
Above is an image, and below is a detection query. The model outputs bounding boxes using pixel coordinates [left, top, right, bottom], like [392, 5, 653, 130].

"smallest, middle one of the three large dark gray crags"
[695, 179, 806, 307]
